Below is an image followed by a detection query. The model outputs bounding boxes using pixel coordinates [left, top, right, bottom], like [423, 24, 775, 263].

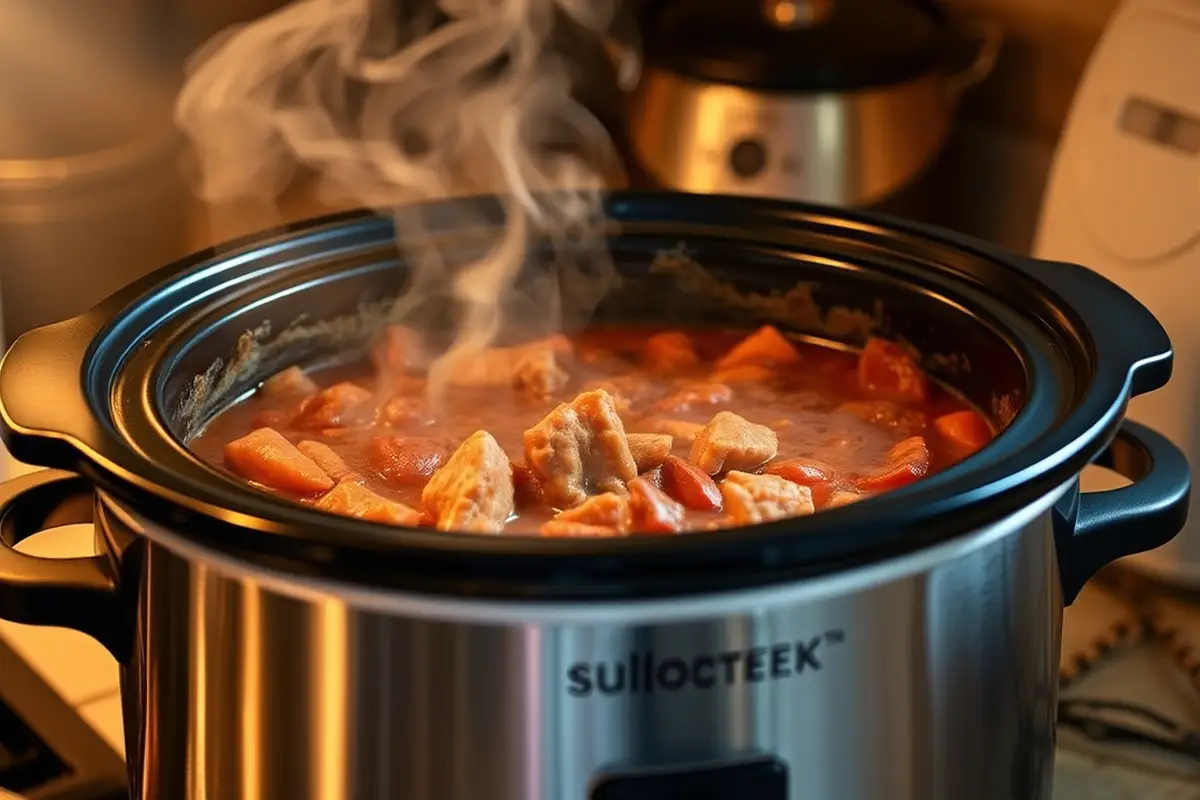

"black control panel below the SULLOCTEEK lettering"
[589, 758, 787, 800]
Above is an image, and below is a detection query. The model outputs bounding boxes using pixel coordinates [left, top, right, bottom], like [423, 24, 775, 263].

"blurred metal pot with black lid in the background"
[629, 0, 1002, 207]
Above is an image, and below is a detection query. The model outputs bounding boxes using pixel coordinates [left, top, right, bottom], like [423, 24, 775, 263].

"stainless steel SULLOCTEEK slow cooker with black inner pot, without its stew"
[0, 194, 1189, 800]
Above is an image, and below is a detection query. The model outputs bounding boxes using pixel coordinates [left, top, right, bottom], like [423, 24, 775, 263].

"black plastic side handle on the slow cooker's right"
[1060, 420, 1192, 604]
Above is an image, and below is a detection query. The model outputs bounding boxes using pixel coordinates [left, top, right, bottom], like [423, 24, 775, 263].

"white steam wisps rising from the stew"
[175, 0, 638, 402]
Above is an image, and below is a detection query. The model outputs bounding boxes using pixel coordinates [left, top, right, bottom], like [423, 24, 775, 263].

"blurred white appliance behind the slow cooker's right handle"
[1034, 0, 1200, 588]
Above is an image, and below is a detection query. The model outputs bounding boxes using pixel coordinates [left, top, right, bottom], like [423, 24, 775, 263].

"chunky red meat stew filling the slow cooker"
[192, 326, 995, 536]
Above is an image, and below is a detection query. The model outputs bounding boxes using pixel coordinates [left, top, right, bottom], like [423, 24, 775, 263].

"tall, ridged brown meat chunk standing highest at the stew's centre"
[524, 390, 637, 509]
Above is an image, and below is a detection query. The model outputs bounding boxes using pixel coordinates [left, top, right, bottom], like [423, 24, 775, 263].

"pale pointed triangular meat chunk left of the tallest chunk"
[421, 431, 512, 534]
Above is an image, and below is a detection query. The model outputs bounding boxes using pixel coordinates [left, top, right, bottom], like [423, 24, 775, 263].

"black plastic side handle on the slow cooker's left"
[0, 470, 120, 656]
